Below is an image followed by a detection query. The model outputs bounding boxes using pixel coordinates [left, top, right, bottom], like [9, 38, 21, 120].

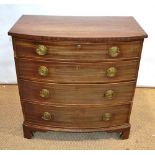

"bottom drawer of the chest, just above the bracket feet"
[23, 102, 130, 128]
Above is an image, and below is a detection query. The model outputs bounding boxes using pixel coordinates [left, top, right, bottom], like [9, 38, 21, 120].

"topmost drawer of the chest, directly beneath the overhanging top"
[15, 40, 143, 62]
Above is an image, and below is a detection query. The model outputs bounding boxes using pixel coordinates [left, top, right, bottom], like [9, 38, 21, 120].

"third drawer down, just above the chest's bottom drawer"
[19, 80, 136, 106]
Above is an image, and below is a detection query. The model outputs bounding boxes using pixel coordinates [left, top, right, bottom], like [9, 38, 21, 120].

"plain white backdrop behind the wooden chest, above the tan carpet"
[0, 0, 155, 87]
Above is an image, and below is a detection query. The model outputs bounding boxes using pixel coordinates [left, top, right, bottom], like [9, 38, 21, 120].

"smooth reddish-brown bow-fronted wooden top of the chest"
[9, 15, 147, 41]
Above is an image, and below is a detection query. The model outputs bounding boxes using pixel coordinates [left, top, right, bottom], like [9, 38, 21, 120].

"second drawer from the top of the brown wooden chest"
[16, 59, 139, 83]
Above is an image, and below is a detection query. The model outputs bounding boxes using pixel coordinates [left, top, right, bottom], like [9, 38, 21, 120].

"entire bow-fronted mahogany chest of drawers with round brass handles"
[9, 15, 147, 139]
